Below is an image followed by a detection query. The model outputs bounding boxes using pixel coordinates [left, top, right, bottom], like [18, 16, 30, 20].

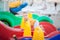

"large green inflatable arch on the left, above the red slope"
[0, 12, 22, 27]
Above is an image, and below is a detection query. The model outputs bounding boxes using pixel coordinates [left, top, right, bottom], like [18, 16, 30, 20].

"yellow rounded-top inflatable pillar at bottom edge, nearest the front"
[32, 27, 44, 40]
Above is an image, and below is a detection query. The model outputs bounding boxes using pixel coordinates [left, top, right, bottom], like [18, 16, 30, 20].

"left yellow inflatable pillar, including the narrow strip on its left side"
[21, 18, 31, 37]
